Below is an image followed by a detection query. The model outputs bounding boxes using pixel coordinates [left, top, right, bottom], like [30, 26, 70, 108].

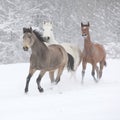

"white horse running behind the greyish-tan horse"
[43, 22, 82, 77]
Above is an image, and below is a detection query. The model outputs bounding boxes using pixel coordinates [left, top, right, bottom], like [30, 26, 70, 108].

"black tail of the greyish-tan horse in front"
[67, 53, 74, 71]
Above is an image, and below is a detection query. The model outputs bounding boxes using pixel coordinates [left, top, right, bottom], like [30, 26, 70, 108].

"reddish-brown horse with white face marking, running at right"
[81, 22, 106, 83]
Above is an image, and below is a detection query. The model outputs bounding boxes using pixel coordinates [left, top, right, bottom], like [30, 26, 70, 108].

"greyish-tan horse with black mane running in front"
[23, 27, 73, 93]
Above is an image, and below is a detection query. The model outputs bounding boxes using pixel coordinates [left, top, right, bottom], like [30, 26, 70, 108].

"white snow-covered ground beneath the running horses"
[0, 59, 120, 120]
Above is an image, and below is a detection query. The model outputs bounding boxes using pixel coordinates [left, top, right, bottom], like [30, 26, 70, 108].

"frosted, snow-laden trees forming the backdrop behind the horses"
[0, 0, 120, 63]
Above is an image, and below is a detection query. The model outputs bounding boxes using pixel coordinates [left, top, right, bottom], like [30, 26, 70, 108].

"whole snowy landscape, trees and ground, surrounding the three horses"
[0, 0, 120, 120]
